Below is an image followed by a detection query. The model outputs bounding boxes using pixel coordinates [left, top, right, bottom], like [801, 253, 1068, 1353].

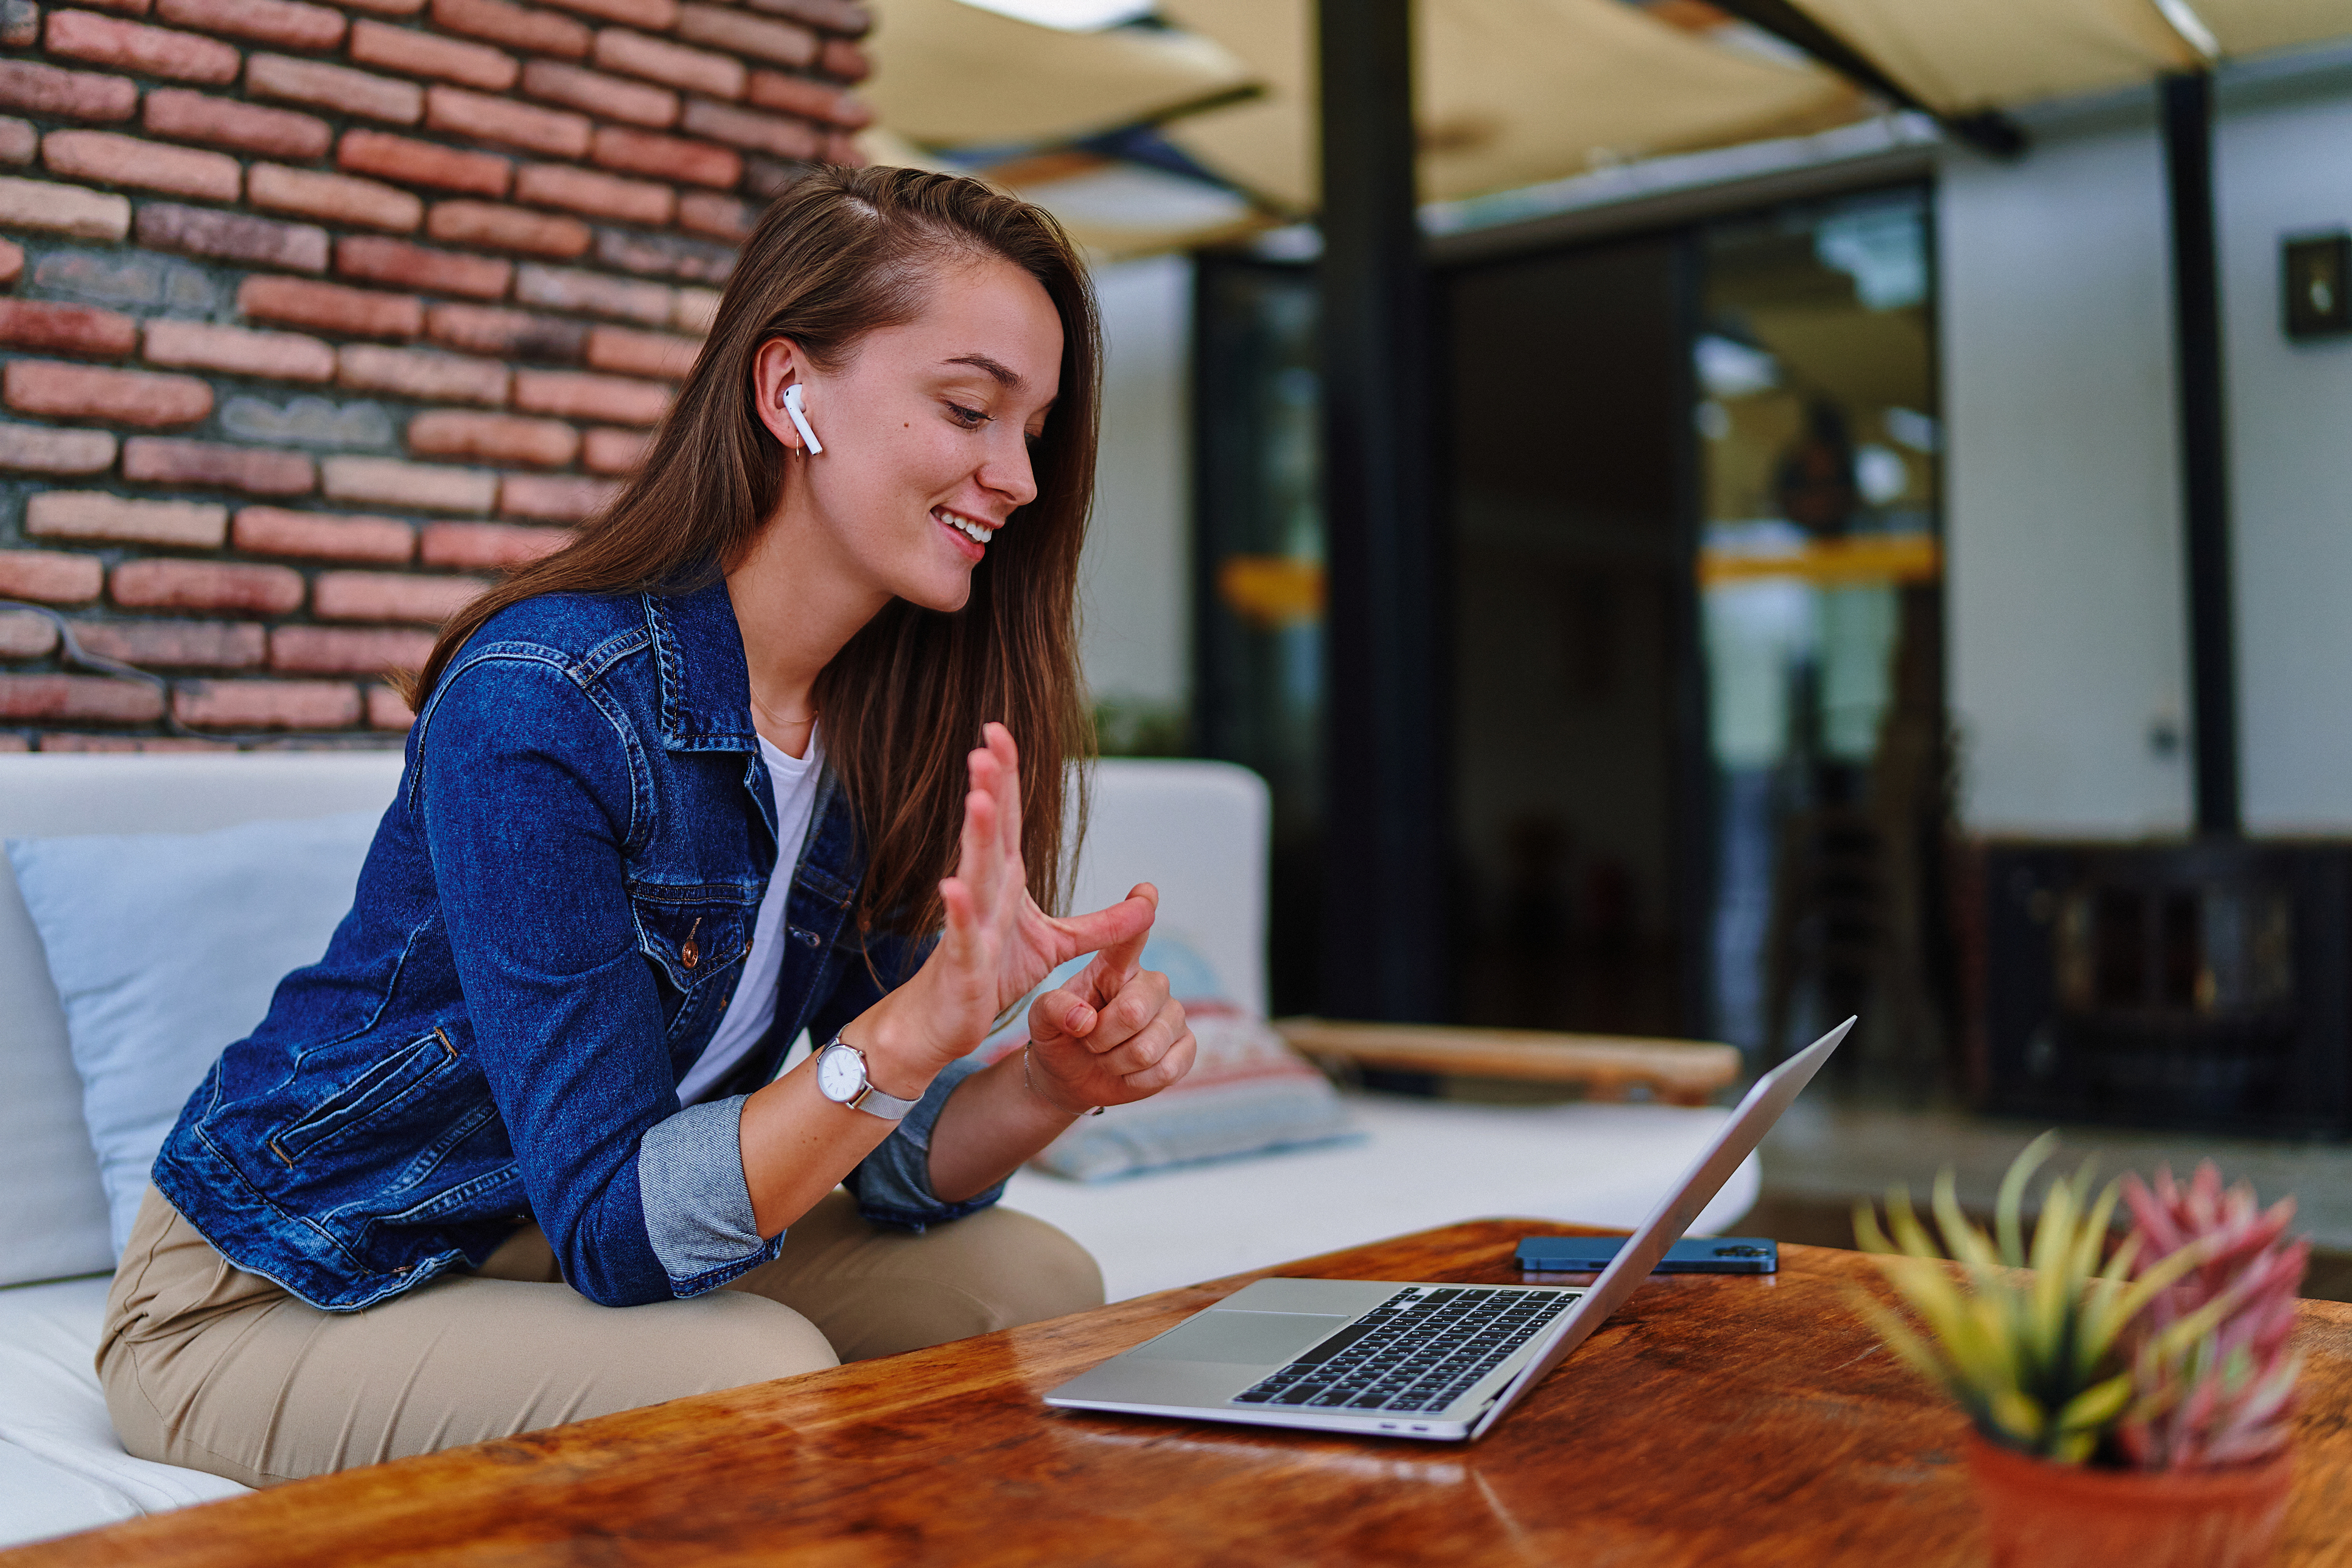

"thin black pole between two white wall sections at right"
[2161, 71, 2244, 837]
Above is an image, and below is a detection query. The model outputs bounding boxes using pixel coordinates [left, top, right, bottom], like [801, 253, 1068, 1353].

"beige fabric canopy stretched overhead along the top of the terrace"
[870, 0, 2352, 212]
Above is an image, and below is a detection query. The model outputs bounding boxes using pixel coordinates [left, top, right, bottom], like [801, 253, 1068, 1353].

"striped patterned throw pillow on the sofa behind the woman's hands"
[981, 938, 1357, 1183]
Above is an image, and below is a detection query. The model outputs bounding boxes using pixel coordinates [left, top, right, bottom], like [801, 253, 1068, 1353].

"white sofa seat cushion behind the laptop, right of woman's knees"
[1004, 1093, 1759, 1300]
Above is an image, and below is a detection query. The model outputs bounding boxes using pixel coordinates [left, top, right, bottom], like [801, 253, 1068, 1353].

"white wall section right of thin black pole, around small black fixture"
[2216, 94, 2352, 832]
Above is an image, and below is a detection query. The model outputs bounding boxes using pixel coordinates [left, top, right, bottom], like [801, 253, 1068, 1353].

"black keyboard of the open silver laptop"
[1230, 1286, 1583, 1413]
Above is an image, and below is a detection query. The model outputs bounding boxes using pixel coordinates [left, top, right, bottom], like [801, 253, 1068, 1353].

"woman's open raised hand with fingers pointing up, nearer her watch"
[903, 724, 1164, 1081]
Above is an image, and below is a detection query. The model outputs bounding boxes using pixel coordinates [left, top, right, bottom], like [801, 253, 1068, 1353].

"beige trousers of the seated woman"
[99, 1189, 1103, 1486]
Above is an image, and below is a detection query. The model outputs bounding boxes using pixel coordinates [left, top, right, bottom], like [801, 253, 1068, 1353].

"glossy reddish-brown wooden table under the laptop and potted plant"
[13, 1220, 2352, 1568]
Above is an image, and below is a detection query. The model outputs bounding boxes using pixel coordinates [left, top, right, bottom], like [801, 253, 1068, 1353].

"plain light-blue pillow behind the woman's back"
[7, 811, 381, 1258]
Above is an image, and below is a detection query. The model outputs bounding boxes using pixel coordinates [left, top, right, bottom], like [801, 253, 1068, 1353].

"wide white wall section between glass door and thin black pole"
[1936, 122, 2189, 837]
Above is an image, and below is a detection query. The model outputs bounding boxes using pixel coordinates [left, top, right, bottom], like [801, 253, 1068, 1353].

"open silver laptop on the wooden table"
[1045, 1018, 1853, 1441]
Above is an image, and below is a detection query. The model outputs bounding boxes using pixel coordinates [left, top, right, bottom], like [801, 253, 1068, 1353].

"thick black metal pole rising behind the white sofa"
[1317, 0, 1449, 1023]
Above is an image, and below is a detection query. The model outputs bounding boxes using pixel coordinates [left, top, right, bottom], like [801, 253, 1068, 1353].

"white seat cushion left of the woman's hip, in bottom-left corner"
[0, 1279, 247, 1547]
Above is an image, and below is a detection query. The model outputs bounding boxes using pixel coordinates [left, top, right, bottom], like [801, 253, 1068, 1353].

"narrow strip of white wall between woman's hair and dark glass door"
[1080, 256, 1192, 710]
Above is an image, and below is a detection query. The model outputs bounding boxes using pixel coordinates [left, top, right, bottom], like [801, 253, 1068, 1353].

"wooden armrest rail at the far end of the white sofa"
[1275, 1018, 1740, 1105]
